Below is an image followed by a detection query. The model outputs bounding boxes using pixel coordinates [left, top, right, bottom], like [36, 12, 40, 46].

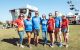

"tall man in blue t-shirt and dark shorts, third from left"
[32, 11, 41, 46]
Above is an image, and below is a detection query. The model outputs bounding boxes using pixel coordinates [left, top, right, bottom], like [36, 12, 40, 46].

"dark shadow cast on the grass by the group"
[1, 38, 50, 45]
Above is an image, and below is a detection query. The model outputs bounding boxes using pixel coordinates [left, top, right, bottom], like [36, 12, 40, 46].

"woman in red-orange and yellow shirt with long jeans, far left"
[14, 14, 24, 48]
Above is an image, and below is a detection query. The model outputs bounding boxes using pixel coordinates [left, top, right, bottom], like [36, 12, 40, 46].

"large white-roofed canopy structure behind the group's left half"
[9, 5, 38, 20]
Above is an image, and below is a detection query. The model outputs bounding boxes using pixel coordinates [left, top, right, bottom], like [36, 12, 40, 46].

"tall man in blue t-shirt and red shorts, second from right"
[55, 11, 62, 47]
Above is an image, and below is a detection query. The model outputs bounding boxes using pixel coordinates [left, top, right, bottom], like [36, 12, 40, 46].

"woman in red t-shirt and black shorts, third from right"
[48, 13, 55, 47]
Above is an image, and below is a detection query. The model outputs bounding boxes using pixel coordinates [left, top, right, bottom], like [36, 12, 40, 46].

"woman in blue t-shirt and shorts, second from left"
[24, 16, 32, 48]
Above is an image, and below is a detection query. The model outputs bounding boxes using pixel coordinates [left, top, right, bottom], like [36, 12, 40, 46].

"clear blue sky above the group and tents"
[0, 0, 80, 21]
